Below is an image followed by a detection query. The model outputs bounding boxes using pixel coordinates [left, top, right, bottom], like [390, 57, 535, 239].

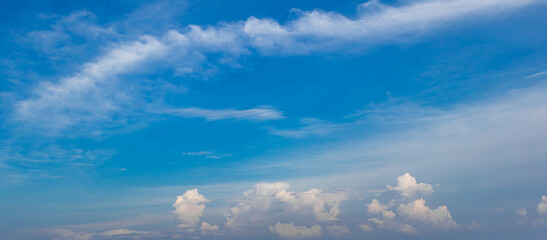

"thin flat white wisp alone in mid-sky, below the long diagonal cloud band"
[156, 106, 284, 121]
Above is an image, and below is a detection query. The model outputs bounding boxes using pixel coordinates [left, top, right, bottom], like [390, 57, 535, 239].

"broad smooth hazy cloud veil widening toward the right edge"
[246, 83, 547, 192]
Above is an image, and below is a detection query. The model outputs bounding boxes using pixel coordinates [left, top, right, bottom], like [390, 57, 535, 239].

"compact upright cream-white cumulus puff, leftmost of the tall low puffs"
[173, 189, 209, 228]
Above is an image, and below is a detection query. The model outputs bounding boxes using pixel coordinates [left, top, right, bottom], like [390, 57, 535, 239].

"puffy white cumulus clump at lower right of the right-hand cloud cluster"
[397, 199, 457, 229]
